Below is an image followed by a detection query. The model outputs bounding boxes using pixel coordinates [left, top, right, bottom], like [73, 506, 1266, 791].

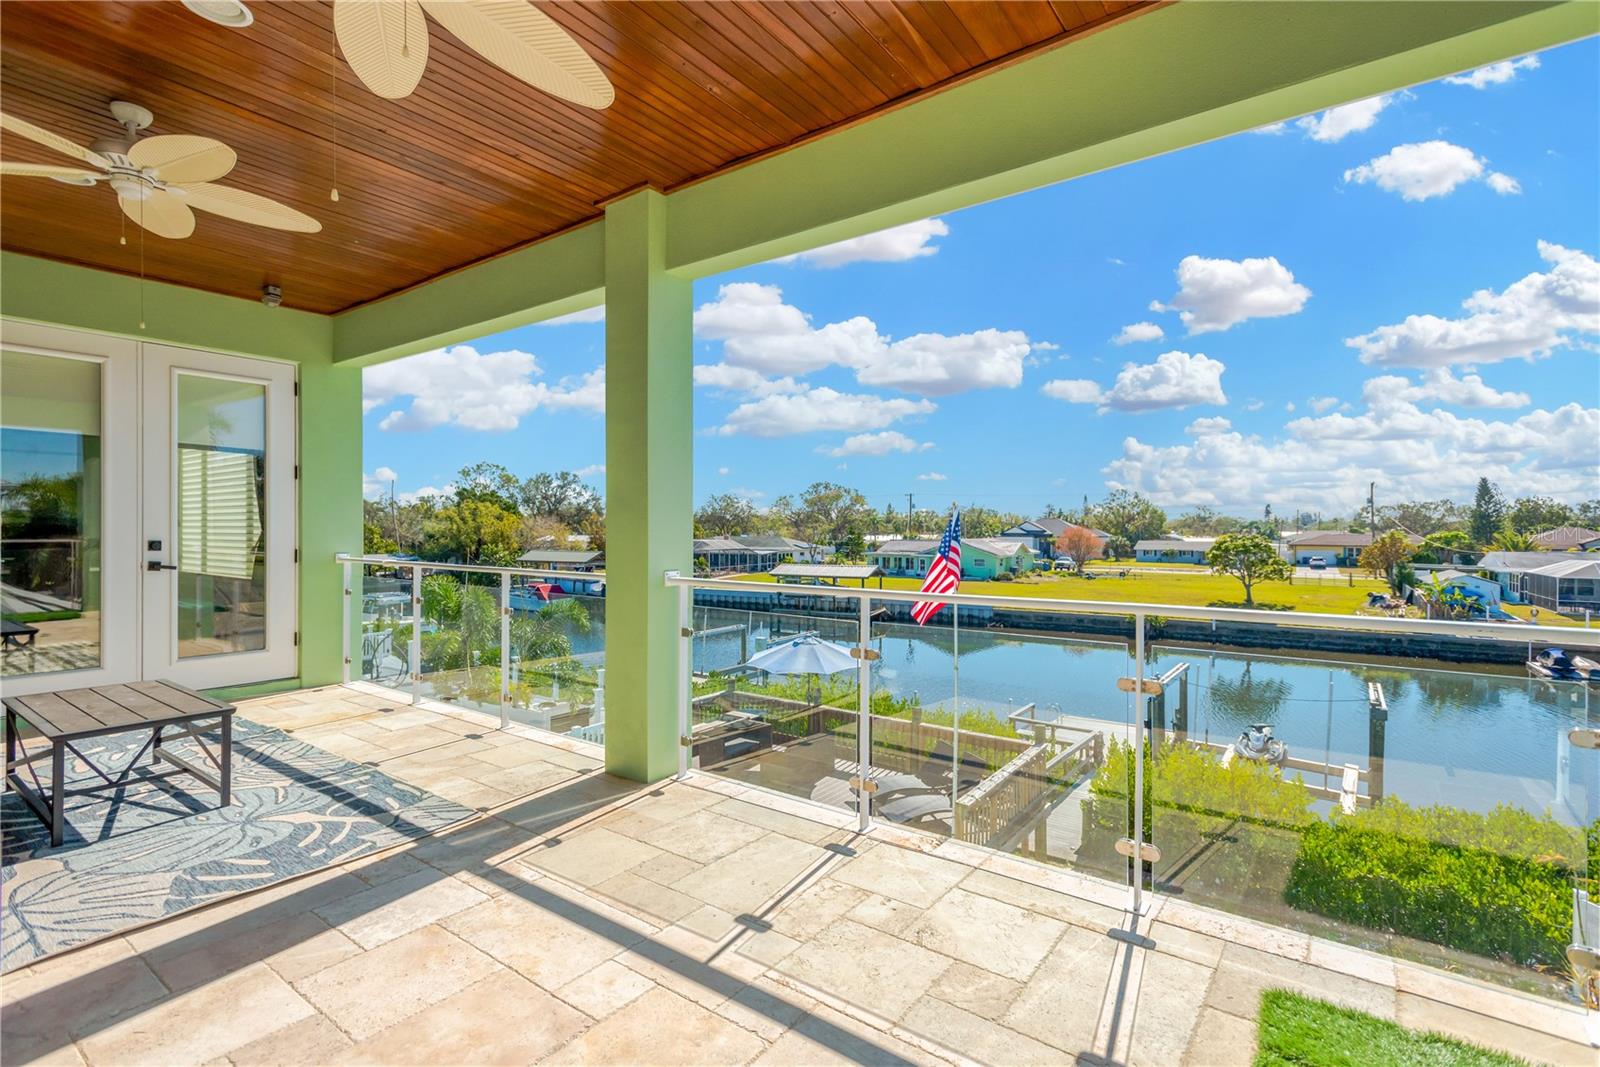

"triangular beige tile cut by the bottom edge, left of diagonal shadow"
[546, 989, 763, 1067]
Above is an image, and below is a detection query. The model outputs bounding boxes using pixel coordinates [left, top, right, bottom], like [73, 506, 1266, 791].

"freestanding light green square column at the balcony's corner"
[605, 190, 694, 782]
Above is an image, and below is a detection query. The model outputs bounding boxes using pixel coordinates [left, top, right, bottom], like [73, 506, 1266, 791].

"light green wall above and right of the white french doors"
[0, 253, 362, 685]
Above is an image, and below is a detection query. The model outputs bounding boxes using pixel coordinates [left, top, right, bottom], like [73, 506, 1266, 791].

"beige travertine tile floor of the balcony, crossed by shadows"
[0, 688, 1600, 1067]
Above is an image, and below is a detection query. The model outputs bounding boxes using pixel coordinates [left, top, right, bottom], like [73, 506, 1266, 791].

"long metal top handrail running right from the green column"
[666, 571, 1600, 648]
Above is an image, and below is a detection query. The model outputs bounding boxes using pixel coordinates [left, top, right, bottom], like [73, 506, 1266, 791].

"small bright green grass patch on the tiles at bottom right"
[1256, 989, 1526, 1067]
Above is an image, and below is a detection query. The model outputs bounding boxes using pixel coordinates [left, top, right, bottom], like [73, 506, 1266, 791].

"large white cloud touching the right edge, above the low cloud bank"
[1344, 242, 1600, 368]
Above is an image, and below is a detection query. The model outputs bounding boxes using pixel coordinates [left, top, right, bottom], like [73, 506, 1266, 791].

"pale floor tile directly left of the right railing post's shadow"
[1003, 926, 1118, 1054]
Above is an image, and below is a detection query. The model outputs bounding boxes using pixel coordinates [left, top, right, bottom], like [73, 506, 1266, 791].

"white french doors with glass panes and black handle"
[0, 322, 298, 694]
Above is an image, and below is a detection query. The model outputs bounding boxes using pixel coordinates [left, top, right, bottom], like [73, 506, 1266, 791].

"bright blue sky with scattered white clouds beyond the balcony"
[365, 40, 1600, 515]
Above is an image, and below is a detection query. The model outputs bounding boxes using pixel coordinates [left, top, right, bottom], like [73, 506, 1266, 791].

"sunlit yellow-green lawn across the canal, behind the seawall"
[739, 571, 1386, 614]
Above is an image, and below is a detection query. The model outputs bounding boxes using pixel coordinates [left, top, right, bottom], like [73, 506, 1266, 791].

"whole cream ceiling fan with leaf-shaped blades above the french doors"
[0, 101, 322, 238]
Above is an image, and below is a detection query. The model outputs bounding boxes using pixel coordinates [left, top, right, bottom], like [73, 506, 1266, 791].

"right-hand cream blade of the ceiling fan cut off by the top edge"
[421, 0, 616, 109]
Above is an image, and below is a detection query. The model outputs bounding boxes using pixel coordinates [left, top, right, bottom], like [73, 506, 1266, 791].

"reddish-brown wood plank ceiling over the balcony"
[0, 0, 1147, 312]
